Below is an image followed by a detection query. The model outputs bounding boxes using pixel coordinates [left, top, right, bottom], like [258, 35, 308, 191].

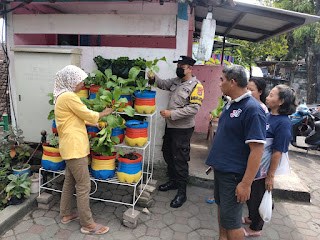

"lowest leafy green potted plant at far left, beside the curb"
[5, 173, 31, 205]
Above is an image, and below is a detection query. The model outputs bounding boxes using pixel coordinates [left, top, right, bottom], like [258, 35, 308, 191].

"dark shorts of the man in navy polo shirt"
[214, 170, 243, 229]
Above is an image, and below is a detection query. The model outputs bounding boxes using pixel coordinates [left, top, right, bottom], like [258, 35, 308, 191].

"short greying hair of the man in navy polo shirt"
[222, 65, 249, 88]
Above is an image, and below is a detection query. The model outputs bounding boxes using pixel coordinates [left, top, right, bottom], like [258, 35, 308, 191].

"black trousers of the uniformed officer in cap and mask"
[162, 127, 194, 184]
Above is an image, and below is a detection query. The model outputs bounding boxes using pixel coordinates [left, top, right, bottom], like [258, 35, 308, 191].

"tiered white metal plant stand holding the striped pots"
[39, 110, 157, 209]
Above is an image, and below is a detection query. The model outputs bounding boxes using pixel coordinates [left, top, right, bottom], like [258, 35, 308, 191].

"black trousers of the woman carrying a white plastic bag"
[247, 178, 266, 231]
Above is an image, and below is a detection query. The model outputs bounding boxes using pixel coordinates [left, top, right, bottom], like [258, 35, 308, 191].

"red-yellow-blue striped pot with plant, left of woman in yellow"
[41, 134, 66, 171]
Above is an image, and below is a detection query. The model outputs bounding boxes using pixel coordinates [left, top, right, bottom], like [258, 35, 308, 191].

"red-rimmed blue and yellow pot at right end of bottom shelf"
[117, 153, 142, 184]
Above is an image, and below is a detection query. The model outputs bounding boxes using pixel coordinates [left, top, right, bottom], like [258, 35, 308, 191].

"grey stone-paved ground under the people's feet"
[1, 152, 320, 240]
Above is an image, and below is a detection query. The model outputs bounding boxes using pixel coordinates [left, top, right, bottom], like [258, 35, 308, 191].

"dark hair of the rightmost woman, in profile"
[275, 84, 297, 115]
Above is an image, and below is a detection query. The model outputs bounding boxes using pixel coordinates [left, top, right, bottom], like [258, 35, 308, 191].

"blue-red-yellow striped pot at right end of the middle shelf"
[124, 120, 148, 147]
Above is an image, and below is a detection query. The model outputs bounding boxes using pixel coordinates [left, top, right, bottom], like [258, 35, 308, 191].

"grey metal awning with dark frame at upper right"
[194, 0, 320, 42]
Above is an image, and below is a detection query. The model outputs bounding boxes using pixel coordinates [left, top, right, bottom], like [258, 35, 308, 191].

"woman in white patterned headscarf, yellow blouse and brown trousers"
[53, 65, 113, 234]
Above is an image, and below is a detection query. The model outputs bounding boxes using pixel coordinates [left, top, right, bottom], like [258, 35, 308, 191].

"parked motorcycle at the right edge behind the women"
[289, 103, 320, 150]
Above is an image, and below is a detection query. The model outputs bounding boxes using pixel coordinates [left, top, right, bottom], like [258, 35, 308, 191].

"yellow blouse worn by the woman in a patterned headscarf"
[54, 92, 99, 160]
